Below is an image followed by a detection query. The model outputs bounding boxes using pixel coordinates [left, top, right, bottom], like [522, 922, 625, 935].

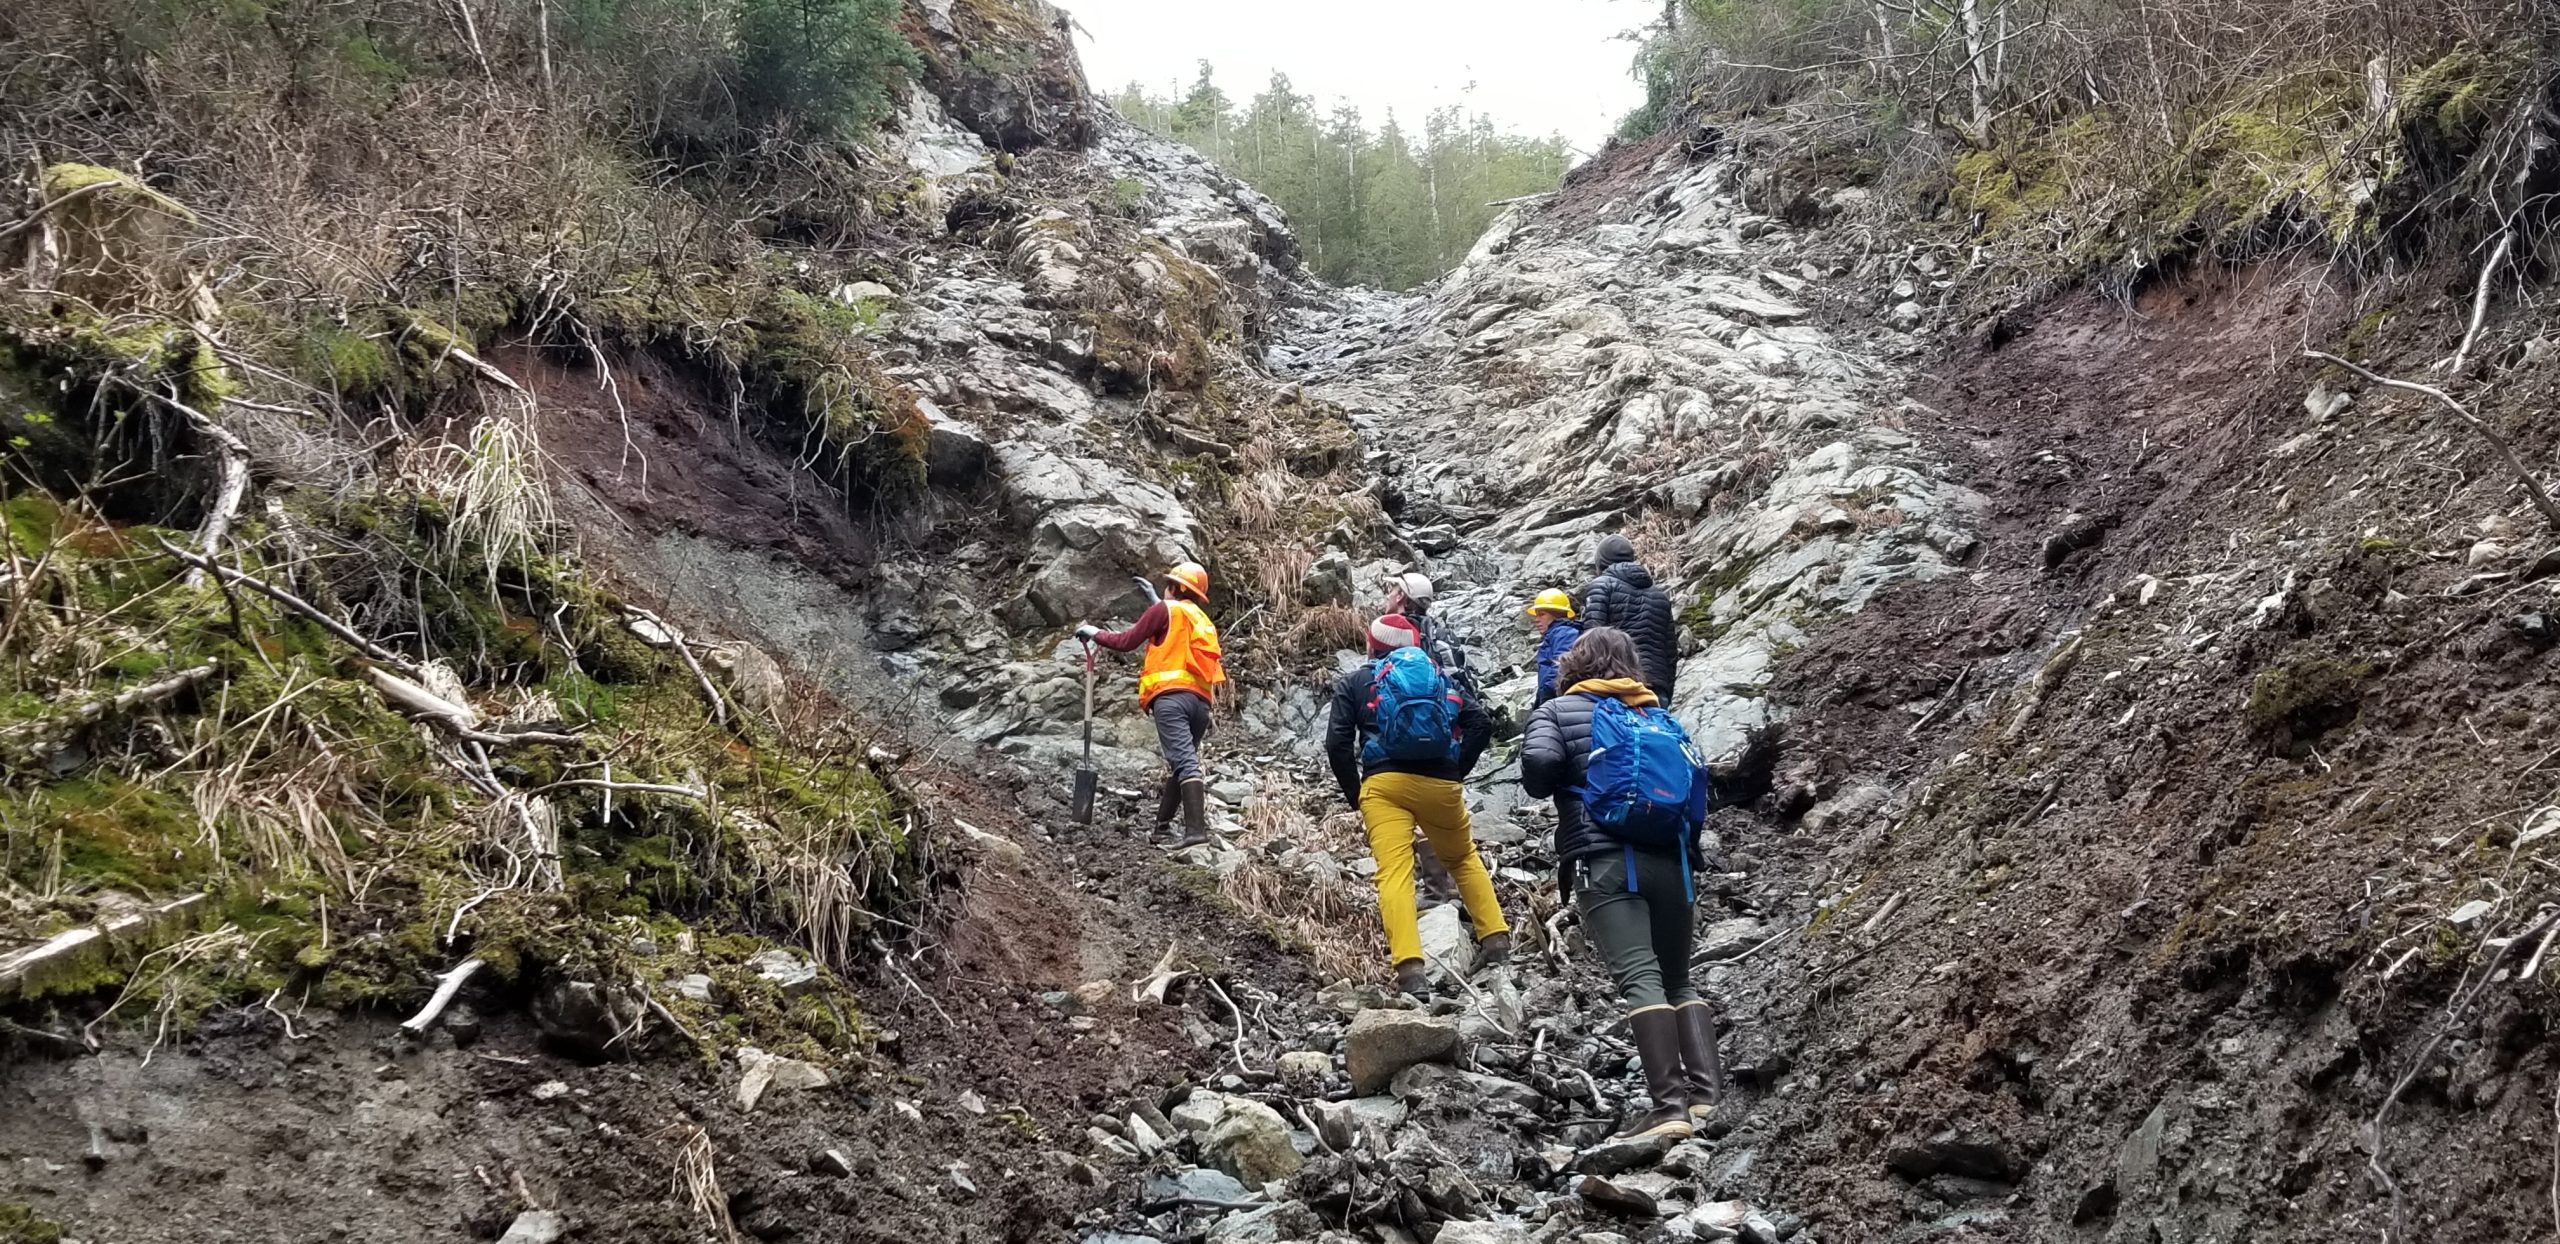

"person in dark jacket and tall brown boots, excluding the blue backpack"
[1521, 627, 1723, 1136]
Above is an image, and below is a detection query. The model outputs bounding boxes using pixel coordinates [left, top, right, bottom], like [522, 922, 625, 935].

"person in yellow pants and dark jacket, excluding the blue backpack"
[1324, 614, 1510, 998]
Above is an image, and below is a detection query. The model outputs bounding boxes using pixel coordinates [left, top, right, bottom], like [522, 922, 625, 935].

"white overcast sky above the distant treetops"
[1057, 0, 1661, 151]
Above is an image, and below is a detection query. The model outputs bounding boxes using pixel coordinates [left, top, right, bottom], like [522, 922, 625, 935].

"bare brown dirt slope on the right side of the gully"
[1743, 269, 2560, 1244]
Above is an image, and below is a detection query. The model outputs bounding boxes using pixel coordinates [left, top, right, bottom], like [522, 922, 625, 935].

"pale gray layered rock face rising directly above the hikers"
[1272, 159, 1984, 760]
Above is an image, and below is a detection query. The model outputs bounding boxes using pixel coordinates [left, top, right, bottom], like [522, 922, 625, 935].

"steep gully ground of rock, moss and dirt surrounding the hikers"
[0, 0, 2560, 1244]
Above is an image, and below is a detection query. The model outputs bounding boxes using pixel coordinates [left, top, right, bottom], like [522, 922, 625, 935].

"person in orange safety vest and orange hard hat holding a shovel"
[1075, 561, 1226, 850]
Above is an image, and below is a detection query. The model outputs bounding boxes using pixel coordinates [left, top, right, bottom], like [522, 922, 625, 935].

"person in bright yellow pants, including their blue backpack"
[1324, 614, 1510, 1001]
